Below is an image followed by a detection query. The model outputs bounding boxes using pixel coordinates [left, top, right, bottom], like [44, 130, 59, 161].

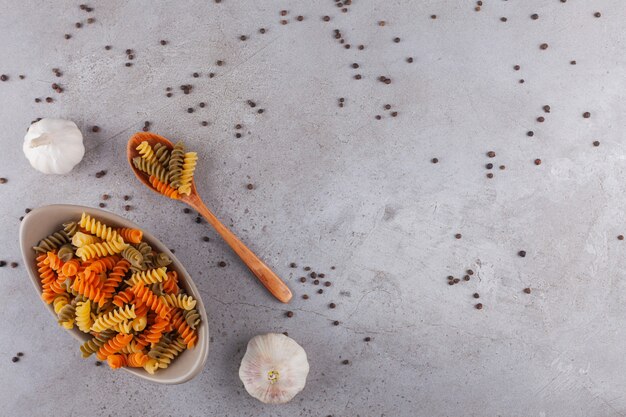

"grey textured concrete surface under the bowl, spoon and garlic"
[0, 0, 626, 417]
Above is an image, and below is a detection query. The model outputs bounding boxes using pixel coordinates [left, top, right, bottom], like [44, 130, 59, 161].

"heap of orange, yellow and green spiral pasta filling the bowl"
[33, 214, 200, 373]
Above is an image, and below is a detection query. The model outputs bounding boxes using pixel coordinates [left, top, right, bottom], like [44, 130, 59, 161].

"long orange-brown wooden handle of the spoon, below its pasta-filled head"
[184, 194, 292, 303]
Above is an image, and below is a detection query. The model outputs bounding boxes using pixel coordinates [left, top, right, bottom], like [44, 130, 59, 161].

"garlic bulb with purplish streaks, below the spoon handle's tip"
[239, 333, 309, 404]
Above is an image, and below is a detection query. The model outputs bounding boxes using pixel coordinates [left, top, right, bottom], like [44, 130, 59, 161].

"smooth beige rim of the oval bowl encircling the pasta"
[19, 204, 209, 384]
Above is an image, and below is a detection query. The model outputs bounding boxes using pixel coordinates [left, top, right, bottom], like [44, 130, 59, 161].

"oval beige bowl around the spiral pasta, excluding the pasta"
[20, 204, 209, 384]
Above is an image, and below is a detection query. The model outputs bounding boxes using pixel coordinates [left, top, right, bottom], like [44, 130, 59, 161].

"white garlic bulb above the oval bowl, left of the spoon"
[22, 119, 85, 174]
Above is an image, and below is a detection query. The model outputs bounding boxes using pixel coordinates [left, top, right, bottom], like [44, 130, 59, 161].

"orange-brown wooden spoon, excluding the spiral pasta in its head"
[126, 132, 292, 303]
